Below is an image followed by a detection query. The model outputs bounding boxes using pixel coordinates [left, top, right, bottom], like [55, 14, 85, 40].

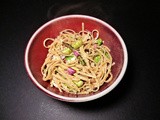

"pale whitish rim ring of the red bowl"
[24, 14, 128, 102]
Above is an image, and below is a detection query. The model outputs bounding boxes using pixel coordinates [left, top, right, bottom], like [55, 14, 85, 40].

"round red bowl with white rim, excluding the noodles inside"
[25, 15, 128, 102]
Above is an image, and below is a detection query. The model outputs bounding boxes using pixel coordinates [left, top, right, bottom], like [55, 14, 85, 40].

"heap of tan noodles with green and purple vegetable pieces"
[41, 23, 113, 94]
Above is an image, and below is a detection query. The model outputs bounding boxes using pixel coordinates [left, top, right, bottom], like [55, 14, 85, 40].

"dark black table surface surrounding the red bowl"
[0, 0, 160, 120]
